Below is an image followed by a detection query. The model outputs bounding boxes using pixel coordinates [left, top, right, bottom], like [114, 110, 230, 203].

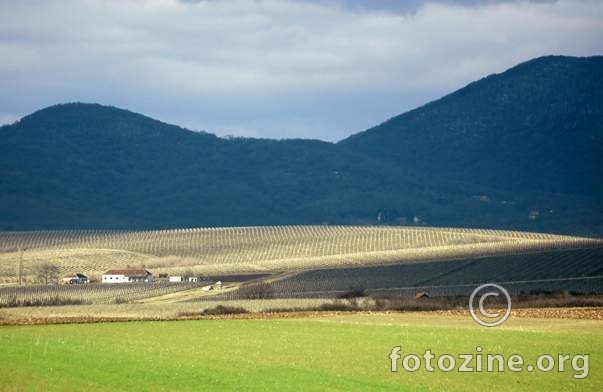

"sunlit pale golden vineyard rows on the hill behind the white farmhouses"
[0, 226, 602, 283]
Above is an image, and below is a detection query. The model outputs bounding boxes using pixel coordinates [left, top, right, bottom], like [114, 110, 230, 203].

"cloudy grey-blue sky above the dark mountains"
[0, 0, 603, 141]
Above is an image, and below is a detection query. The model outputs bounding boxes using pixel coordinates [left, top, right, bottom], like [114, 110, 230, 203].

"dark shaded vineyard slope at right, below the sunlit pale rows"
[221, 248, 603, 299]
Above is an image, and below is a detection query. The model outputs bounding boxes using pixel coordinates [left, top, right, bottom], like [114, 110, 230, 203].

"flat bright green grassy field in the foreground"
[0, 313, 603, 391]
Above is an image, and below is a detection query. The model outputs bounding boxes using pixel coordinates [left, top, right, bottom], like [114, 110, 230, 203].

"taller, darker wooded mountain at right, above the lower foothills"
[340, 56, 603, 198]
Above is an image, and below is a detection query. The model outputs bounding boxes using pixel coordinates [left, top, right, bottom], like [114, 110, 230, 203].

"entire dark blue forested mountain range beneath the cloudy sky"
[0, 57, 603, 236]
